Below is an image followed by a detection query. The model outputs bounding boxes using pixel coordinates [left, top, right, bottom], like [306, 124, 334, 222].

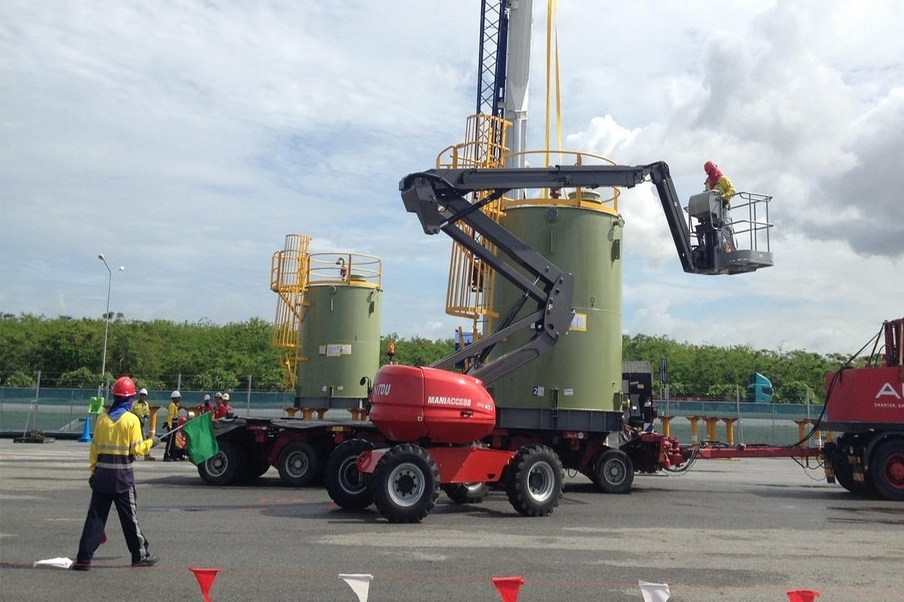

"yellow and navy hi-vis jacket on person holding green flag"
[88, 412, 154, 493]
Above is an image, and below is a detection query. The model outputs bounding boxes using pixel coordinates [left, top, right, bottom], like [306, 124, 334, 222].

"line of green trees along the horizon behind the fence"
[0, 314, 865, 403]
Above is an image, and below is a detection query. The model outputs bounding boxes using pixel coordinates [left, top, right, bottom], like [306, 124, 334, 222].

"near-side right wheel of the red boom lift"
[505, 445, 565, 516]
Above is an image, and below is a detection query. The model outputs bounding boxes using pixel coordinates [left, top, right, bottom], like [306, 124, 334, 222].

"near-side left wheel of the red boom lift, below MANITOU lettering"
[370, 443, 439, 523]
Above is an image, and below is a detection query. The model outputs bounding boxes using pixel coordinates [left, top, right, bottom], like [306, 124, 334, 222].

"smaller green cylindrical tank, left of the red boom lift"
[296, 274, 382, 408]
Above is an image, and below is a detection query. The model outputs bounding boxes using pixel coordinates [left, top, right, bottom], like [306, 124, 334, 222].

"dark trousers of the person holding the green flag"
[76, 485, 151, 564]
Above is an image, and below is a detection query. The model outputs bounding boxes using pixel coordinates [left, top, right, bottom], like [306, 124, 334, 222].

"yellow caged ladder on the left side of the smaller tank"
[270, 234, 311, 391]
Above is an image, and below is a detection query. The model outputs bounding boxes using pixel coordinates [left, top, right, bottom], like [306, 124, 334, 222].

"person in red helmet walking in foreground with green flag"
[72, 376, 159, 571]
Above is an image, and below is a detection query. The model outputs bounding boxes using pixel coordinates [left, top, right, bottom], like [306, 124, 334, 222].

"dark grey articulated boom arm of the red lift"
[399, 162, 772, 384]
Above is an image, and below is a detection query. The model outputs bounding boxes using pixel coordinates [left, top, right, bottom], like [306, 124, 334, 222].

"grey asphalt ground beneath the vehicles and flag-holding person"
[0, 440, 904, 602]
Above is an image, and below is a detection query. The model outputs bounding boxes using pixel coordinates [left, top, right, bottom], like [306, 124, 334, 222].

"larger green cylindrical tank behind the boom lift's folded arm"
[489, 199, 623, 411]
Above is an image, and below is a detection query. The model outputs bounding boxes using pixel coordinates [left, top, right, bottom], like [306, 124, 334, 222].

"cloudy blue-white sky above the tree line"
[0, 0, 904, 359]
